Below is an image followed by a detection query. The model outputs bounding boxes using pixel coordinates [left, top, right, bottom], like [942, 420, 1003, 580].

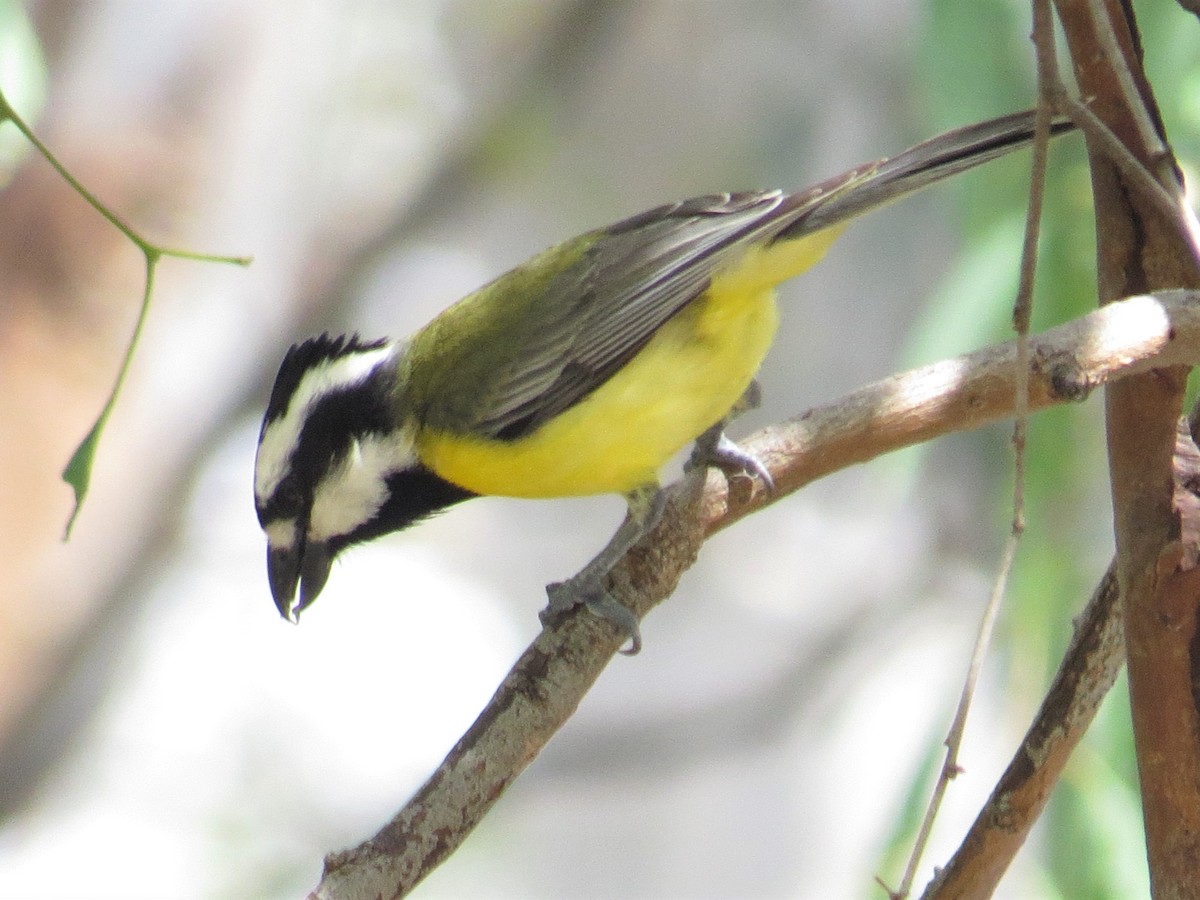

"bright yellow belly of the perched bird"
[418, 283, 778, 498]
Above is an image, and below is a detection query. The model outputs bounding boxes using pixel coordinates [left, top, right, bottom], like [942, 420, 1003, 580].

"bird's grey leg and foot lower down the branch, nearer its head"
[541, 484, 667, 656]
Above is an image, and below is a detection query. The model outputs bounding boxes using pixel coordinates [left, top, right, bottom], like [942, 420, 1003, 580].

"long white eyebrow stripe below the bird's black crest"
[254, 343, 396, 503]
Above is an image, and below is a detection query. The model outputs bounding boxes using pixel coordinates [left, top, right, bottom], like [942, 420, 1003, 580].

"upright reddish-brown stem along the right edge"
[1057, 0, 1200, 898]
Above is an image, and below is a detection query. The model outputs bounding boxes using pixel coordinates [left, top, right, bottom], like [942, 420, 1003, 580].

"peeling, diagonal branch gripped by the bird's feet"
[312, 292, 1200, 900]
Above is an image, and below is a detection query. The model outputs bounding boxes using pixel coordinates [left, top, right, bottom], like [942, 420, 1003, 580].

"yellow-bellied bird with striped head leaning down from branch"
[254, 110, 1074, 653]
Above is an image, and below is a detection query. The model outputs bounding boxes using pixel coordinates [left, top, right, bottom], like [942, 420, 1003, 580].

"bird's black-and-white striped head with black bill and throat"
[254, 335, 470, 620]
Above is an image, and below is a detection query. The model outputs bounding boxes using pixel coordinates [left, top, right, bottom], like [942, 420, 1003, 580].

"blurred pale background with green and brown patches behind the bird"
[0, 0, 1200, 898]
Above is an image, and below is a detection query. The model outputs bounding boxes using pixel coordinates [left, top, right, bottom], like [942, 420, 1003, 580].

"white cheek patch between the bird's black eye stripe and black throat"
[308, 434, 416, 541]
